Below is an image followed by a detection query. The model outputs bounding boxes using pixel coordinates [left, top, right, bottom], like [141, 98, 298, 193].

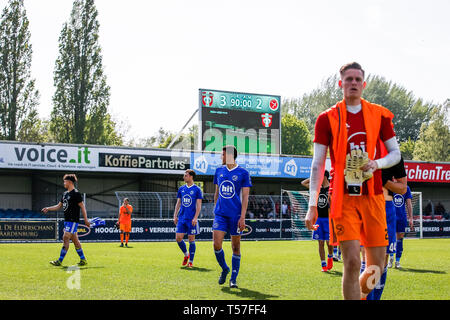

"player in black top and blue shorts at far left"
[42, 174, 90, 266]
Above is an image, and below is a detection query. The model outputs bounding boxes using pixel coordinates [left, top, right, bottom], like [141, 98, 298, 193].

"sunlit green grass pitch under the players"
[0, 239, 450, 300]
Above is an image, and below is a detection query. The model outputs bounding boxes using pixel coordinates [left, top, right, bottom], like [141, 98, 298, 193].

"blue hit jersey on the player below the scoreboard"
[214, 165, 252, 217]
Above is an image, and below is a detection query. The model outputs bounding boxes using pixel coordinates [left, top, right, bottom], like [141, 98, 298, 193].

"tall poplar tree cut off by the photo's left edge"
[0, 0, 39, 140]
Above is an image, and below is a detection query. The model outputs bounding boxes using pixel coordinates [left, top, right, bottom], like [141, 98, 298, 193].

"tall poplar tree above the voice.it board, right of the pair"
[50, 0, 123, 145]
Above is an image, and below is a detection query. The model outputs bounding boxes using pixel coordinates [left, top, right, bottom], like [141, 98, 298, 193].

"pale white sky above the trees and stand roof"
[0, 0, 450, 139]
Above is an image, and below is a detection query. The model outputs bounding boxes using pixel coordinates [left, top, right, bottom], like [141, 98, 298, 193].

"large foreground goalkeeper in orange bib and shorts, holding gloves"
[305, 63, 400, 299]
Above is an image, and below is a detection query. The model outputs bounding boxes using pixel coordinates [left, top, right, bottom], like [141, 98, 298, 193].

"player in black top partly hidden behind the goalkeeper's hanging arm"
[302, 170, 333, 272]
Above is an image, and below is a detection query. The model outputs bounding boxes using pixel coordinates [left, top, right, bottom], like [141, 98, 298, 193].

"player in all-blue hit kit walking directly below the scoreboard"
[213, 146, 252, 288]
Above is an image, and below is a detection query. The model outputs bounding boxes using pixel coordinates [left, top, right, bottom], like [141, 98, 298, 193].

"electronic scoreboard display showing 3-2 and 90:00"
[199, 89, 281, 154]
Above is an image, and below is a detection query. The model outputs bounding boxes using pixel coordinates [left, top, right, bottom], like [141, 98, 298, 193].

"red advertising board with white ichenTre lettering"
[405, 161, 450, 183]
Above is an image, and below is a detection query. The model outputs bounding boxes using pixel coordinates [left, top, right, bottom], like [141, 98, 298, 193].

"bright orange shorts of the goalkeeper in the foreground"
[330, 194, 389, 247]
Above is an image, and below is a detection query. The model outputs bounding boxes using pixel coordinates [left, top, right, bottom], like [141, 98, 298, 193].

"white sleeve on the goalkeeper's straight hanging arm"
[309, 143, 328, 207]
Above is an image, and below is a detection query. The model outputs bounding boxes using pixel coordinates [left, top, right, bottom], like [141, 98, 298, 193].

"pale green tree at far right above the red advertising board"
[413, 104, 450, 162]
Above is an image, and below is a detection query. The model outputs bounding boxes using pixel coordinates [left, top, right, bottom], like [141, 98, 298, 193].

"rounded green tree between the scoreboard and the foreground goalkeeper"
[281, 114, 312, 155]
